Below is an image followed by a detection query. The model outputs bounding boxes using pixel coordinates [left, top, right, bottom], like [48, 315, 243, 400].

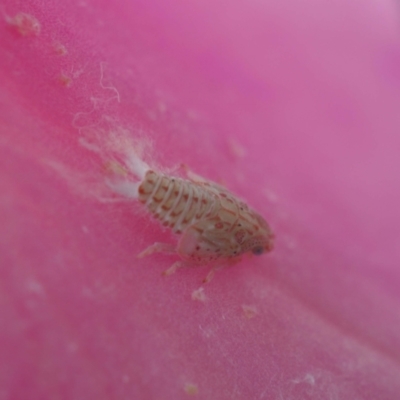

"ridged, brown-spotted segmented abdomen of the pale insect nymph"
[138, 170, 219, 233]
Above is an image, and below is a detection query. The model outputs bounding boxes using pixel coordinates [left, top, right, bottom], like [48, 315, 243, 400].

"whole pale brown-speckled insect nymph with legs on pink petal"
[138, 169, 273, 281]
